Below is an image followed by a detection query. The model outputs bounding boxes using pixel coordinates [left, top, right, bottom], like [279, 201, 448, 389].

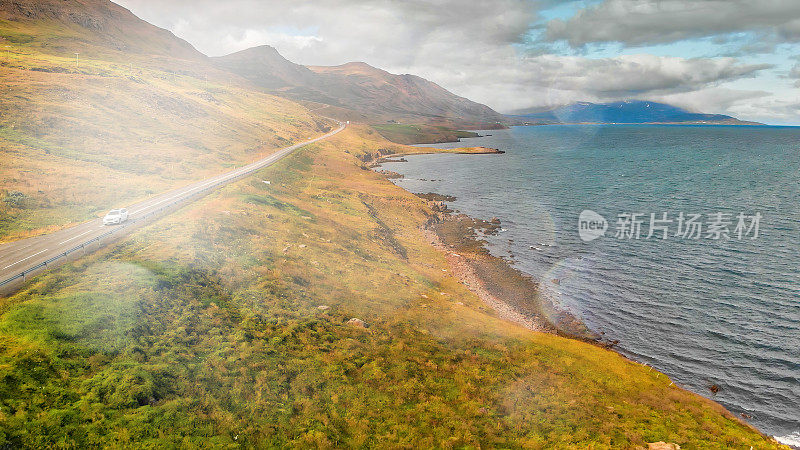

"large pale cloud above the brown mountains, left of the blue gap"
[118, 0, 537, 64]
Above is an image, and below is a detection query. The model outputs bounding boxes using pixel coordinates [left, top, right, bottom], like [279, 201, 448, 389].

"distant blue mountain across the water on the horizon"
[511, 100, 760, 125]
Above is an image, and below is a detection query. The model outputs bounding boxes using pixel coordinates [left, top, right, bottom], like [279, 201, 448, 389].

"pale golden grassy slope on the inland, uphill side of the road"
[0, 20, 332, 241]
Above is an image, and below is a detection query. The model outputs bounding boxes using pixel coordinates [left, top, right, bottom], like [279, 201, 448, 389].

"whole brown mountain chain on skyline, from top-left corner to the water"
[0, 0, 505, 128]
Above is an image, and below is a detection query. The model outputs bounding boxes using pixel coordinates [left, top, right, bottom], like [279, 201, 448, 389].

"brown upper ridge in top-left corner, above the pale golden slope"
[0, 0, 206, 60]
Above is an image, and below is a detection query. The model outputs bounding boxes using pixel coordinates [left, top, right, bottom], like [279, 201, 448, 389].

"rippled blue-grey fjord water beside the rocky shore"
[384, 125, 800, 445]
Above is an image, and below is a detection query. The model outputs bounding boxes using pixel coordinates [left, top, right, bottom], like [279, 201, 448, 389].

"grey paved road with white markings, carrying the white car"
[0, 123, 346, 292]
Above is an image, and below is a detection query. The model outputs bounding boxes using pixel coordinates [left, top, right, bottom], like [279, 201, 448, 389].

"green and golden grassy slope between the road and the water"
[0, 126, 775, 449]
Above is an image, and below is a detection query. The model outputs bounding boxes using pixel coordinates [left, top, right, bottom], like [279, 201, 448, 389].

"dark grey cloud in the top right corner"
[545, 0, 800, 47]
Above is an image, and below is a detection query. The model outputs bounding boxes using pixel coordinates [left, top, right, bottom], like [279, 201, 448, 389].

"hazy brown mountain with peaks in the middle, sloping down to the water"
[213, 46, 505, 126]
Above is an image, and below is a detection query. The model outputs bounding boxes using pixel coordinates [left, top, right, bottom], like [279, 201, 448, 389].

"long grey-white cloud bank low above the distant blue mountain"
[438, 55, 770, 112]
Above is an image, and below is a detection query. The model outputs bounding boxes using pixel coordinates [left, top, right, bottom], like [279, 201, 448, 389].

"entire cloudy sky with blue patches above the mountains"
[115, 0, 800, 125]
